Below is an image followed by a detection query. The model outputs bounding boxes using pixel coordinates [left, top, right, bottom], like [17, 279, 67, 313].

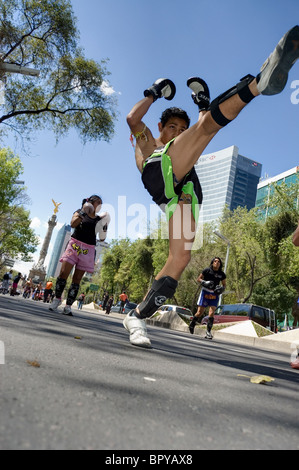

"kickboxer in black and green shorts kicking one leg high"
[123, 26, 299, 348]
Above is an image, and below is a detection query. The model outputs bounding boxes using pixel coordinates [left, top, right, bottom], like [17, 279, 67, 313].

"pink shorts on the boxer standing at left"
[59, 238, 95, 273]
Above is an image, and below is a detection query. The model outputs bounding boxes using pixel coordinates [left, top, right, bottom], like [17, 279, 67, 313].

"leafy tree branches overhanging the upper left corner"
[0, 0, 116, 143]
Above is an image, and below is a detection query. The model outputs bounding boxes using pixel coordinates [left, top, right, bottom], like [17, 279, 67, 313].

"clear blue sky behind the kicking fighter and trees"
[7, 0, 299, 273]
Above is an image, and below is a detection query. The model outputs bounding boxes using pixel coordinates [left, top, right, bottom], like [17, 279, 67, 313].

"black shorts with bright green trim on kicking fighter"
[142, 140, 202, 222]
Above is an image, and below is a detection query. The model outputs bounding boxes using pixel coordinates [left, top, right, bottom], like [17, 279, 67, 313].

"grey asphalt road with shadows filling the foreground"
[0, 295, 299, 453]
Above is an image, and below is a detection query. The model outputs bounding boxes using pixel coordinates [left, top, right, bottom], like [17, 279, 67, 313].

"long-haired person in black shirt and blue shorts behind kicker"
[189, 257, 226, 339]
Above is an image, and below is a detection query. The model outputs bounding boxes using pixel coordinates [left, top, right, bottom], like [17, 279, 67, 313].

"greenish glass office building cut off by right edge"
[255, 166, 299, 219]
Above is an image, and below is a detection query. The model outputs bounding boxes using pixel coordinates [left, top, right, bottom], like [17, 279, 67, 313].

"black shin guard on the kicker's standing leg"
[138, 276, 178, 318]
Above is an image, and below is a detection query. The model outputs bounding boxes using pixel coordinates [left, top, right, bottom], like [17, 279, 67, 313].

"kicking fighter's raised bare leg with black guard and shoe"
[169, 26, 299, 179]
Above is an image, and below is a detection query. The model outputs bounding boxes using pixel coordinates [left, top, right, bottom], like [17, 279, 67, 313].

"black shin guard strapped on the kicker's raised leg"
[209, 74, 255, 127]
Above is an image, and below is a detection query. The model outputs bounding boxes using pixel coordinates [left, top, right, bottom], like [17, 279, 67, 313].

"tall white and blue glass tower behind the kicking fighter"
[195, 145, 262, 223]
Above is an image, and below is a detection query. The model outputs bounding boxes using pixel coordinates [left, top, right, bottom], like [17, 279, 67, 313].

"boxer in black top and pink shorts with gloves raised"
[49, 194, 110, 316]
